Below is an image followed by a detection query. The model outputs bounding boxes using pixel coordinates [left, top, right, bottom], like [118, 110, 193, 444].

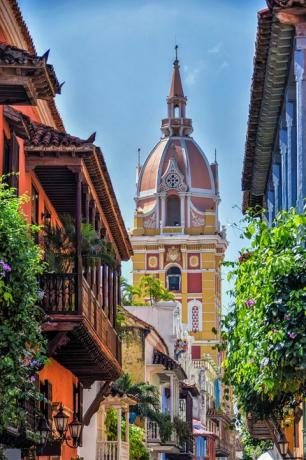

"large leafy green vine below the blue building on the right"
[221, 209, 306, 418]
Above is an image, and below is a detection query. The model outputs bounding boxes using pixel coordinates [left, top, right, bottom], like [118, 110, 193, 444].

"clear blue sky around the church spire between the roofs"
[20, 0, 266, 310]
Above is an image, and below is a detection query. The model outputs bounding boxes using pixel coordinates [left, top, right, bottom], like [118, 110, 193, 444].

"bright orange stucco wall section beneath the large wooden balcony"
[39, 359, 78, 460]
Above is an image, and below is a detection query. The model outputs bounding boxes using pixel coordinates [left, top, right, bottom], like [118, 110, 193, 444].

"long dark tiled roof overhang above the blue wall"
[242, 10, 293, 212]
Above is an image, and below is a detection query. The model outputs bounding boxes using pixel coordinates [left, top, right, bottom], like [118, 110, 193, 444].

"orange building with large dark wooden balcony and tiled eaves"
[0, 0, 133, 460]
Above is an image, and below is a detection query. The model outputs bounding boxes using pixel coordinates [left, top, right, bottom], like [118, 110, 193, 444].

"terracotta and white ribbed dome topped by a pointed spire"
[136, 47, 219, 232]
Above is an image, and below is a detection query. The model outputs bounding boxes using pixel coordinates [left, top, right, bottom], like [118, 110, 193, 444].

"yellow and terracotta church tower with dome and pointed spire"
[131, 47, 226, 361]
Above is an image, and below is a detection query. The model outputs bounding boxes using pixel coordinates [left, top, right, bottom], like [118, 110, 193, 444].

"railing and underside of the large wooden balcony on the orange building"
[41, 273, 121, 387]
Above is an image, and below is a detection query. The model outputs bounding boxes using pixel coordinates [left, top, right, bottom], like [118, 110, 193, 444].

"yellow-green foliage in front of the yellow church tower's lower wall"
[121, 275, 175, 306]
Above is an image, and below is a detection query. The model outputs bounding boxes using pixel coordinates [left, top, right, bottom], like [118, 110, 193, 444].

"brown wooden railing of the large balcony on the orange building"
[40, 273, 121, 364]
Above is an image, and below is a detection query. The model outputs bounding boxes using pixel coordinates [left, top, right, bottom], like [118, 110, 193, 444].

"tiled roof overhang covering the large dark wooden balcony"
[4, 106, 133, 260]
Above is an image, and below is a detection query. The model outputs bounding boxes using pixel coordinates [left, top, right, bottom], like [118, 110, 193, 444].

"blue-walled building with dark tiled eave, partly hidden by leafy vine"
[242, 0, 306, 458]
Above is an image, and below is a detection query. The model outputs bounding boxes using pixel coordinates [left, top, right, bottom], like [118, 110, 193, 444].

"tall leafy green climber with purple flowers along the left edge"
[0, 180, 46, 434]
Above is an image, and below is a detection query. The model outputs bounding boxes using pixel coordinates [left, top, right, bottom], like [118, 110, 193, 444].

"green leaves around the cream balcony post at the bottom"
[105, 409, 149, 460]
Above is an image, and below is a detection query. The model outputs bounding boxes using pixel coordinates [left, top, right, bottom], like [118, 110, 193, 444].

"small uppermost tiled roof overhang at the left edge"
[0, 43, 61, 100]
